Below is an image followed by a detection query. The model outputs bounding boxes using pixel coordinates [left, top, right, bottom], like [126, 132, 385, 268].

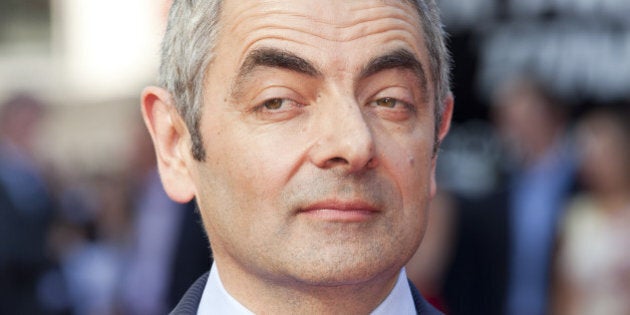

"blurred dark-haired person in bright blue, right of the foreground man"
[494, 77, 576, 315]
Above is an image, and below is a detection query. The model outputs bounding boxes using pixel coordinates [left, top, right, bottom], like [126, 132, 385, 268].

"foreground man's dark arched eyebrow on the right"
[359, 48, 428, 99]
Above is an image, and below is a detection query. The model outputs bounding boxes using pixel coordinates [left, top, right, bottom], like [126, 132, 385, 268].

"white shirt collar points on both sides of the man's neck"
[197, 264, 416, 315]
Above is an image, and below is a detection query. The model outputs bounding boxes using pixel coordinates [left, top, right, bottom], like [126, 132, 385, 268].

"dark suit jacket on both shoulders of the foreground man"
[171, 273, 442, 315]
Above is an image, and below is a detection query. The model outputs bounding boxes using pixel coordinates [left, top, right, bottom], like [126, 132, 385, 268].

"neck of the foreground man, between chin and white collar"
[215, 256, 400, 314]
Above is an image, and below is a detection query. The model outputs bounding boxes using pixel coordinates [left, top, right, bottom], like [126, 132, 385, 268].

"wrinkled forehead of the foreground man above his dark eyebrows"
[215, 0, 428, 76]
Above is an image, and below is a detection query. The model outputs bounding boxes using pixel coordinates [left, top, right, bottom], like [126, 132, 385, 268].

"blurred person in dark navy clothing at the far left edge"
[0, 94, 55, 314]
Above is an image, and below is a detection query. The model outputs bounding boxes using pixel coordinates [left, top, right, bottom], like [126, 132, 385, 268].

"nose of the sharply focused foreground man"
[309, 100, 378, 174]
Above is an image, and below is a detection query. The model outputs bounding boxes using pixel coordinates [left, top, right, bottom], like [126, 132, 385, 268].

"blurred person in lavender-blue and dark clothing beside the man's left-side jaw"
[121, 119, 212, 315]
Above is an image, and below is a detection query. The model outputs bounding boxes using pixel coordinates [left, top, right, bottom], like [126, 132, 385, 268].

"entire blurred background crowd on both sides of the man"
[0, 75, 630, 315]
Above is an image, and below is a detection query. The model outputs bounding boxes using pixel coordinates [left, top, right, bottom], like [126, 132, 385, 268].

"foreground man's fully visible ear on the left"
[141, 86, 195, 203]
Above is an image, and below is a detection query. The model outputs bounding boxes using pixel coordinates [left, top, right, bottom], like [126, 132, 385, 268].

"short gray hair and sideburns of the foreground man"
[158, 0, 451, 161]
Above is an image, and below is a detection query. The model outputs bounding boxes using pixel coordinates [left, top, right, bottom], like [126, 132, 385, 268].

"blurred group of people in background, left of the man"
[0, 93, 211, 314]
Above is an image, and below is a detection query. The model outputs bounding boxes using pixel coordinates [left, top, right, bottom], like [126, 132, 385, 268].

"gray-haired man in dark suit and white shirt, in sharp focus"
[142, 0, 453, 314]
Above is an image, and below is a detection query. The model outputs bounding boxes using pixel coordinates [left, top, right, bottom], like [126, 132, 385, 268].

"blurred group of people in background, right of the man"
[407, 74, 630, 315]
